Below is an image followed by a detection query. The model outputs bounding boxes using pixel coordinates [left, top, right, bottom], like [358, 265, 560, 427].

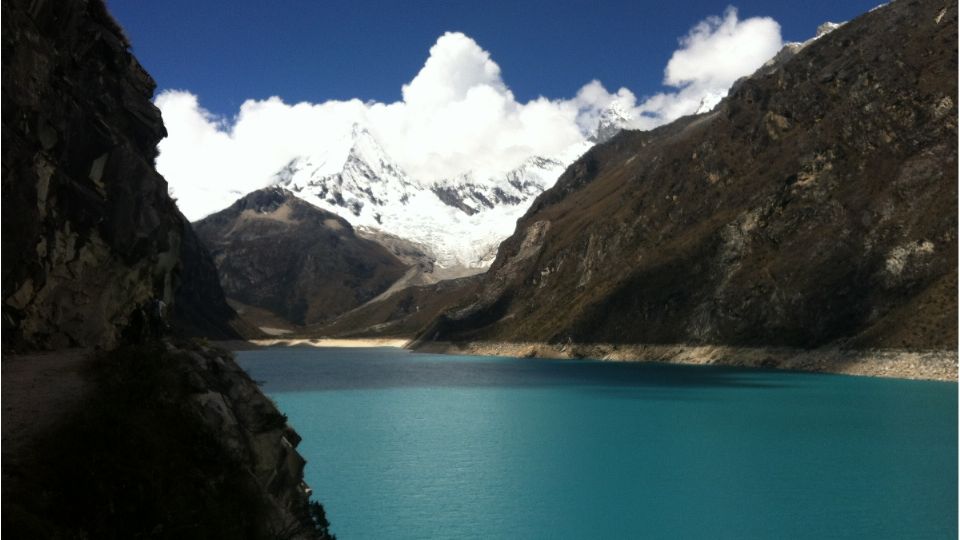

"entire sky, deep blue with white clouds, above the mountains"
[108, 0, 877, 219]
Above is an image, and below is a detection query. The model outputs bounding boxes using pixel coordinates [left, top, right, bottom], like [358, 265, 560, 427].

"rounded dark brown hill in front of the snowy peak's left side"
[194, 188, 407, 325]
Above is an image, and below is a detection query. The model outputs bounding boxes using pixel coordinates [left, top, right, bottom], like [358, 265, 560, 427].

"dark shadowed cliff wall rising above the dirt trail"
[3, 0, 244, 349]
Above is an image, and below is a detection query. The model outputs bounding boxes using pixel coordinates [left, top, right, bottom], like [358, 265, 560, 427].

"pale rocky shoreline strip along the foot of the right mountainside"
[416, 342, 957, 382]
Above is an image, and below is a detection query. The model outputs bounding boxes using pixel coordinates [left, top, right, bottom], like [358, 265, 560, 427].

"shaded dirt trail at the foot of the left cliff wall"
[0, 349, 91, 479]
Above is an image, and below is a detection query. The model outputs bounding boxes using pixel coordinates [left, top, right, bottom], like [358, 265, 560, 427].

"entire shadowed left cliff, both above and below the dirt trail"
[2, 0, 326, 538]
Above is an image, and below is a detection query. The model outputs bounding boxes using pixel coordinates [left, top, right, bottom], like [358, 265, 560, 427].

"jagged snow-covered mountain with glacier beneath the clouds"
[274, 125, 588, 273]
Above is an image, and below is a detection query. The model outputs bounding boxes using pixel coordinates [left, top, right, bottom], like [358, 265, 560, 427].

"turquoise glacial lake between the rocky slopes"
[237, 348, 958, 540]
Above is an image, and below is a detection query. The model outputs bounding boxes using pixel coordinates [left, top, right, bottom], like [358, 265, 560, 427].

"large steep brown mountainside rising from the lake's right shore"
[422, 0, 957, 349]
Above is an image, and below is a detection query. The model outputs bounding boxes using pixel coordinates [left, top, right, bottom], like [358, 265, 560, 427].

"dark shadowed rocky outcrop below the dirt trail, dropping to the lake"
[3, 342, 329, 539]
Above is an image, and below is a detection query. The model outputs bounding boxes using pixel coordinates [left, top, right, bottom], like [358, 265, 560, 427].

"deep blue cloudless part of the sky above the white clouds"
[108, 0, 878, 116]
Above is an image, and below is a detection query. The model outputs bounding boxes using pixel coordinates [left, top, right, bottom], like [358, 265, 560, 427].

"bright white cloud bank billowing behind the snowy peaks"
[156, 8, 780, 219]
